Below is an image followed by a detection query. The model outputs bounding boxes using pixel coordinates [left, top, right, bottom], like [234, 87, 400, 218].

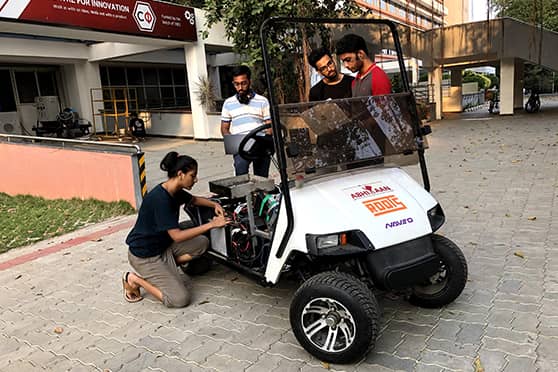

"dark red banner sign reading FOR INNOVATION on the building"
[0, 0, 197, 41]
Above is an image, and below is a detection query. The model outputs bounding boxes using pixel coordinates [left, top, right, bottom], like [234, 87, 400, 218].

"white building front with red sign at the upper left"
[0, 0, 236, 139]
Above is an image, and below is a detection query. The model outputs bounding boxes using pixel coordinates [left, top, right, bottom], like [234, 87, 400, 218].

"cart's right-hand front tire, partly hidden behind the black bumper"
[409, 234, 467, 308]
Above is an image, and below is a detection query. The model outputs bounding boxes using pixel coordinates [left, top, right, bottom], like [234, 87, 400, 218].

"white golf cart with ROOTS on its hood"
[186, 18, 467, 363]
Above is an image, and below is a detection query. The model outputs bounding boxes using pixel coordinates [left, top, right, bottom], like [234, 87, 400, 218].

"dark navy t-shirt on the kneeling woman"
[126, 185, 192, 258]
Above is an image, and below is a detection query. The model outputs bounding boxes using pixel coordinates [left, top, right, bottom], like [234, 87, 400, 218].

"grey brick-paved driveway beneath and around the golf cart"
[0, 109, 558, 372]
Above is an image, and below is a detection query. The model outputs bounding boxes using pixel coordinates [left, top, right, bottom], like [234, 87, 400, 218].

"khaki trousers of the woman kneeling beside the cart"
[128, 235, 209, 307]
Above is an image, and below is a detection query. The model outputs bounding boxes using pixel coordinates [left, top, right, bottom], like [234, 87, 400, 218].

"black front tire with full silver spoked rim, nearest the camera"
[289, 271, 379, 364]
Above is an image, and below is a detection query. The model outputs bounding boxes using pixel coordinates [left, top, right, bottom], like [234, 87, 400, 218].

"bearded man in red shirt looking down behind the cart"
[336, 34, 391, 97]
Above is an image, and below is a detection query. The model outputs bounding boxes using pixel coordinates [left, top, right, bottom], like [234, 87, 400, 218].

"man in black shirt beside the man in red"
[308, 48, 353, 101]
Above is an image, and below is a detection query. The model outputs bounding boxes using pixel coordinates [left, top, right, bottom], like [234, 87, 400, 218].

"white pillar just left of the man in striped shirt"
[184, 40, 210, 139]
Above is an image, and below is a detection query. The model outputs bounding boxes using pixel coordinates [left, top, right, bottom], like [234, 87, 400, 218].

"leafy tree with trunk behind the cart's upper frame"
[199, 0, 359, 101]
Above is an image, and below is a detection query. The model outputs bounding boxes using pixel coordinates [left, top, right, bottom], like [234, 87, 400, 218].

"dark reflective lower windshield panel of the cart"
[278, 94, 417, 178]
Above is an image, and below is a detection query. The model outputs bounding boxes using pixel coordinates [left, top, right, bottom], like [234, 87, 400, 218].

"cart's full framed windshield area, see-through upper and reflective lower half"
[263, 19, 427, 179]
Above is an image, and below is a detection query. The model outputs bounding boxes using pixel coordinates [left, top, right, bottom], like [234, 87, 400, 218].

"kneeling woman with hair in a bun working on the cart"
[122, 151, 227, 307]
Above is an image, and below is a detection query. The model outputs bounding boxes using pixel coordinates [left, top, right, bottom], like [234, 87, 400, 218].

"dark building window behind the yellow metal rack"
[101, 66, 191, 110]
